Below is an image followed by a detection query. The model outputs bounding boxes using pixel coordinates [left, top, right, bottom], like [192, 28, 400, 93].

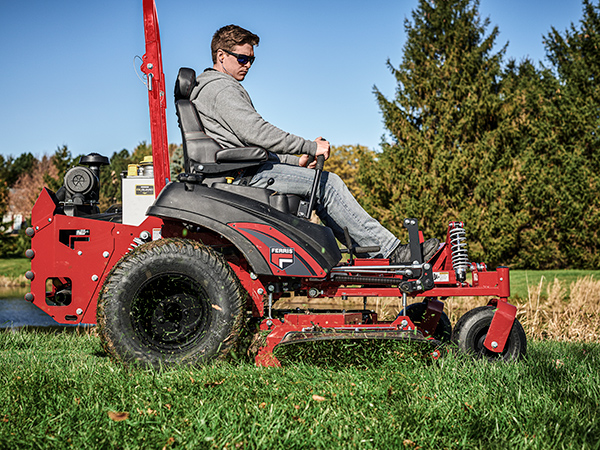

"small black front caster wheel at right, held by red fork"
[452, 306, 527, 361]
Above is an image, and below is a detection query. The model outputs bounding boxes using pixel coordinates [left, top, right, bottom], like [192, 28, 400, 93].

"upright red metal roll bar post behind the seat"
[141, 0, 171, 196]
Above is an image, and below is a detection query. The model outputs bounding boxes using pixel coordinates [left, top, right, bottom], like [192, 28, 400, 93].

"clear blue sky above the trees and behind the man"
[0, 0, 582, 157]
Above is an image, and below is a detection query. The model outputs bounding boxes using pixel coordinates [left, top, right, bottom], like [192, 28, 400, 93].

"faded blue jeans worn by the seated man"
[238, 160, 400, 257]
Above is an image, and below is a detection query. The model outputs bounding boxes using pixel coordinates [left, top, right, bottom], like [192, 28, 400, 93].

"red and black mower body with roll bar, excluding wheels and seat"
[26, 0, 516, 365]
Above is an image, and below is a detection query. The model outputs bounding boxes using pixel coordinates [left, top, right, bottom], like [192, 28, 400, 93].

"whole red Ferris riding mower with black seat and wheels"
[26, 0, 526, 366]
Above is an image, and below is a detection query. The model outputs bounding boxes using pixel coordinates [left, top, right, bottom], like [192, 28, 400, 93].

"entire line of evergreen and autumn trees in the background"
[0, 0, 600, 269]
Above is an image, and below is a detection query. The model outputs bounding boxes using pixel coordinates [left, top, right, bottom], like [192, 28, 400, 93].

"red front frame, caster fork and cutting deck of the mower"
[247, 227, 516, 366]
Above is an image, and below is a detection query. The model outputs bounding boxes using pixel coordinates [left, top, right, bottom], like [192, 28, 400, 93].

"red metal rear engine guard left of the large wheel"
[26, 189, 163, 324]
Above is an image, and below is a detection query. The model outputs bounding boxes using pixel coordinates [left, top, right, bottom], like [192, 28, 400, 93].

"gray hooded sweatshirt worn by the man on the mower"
[190, 69, 317, 165]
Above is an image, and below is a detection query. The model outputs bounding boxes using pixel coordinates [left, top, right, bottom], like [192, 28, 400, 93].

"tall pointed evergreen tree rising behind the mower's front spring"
[359, 0, 512, 261]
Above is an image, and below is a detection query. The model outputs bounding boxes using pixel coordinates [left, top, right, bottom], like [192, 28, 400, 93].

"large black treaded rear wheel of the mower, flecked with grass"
[97, 239, 245, 367]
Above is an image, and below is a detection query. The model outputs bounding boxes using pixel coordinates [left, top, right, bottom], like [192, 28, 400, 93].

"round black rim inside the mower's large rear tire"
[131, 274, 210, 353]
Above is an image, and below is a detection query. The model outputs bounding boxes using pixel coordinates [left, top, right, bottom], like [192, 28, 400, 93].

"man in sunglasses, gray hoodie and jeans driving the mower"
[190, 25, 439, 264]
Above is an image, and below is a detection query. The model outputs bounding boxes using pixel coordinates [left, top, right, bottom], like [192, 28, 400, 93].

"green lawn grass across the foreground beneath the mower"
[0, 330, 600, 449]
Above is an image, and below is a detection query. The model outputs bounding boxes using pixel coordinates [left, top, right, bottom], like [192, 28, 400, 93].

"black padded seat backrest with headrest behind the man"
[175, 67, 221, 173]
